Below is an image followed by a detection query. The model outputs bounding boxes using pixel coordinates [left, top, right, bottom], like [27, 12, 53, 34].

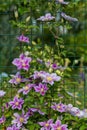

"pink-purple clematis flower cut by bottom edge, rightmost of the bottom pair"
[51, 120, 68, 130]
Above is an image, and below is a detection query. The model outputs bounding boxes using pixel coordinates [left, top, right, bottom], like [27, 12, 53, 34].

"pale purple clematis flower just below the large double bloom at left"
[9, 72, 25, 85]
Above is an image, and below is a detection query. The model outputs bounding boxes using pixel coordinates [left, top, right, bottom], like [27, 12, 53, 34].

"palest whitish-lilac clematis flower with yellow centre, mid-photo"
[42, 73, 61, 85]
